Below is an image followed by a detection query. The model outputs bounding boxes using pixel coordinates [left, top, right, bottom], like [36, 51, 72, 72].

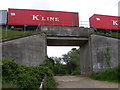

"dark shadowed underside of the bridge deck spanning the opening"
[47, 37, 88, 46]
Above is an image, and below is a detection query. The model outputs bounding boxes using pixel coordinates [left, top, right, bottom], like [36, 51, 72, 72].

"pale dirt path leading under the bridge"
[54, 76, 118, 88]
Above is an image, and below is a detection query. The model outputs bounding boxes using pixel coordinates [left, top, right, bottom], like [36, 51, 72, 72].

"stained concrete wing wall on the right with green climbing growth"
[91, 34, 120, 72]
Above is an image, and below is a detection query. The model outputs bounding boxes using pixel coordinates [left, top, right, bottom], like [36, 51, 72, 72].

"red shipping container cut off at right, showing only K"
[89, 14, 120, 30]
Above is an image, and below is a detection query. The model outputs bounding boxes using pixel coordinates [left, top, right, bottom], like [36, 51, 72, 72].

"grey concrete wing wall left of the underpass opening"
[2, 33, 47, 66]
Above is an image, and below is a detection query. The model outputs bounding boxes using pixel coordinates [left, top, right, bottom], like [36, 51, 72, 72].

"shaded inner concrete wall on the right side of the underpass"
[80, 41, 92, 74]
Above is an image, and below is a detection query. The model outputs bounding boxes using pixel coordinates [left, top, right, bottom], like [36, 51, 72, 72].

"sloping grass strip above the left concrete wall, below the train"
[0, 28, 38, 39]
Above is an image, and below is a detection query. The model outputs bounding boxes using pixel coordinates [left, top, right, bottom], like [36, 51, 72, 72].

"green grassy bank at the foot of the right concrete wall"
[90, 65, 120, 83]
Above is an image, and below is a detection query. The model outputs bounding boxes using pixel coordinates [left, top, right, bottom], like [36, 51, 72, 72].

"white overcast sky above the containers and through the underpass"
[0, 0, 120, 57]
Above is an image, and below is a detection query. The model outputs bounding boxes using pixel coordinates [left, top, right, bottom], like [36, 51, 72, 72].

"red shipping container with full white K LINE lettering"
[8, 9, 79, 27]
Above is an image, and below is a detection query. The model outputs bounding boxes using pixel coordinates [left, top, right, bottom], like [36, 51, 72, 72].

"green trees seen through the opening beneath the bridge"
[44, 48, 80, 75]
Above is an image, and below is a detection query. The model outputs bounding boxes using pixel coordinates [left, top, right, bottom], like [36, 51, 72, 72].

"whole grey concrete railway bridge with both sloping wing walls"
[2, 26, 120, 74]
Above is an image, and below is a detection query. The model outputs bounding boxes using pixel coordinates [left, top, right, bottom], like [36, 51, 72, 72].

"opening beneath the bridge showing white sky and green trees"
[47, 46, 80, 76]
